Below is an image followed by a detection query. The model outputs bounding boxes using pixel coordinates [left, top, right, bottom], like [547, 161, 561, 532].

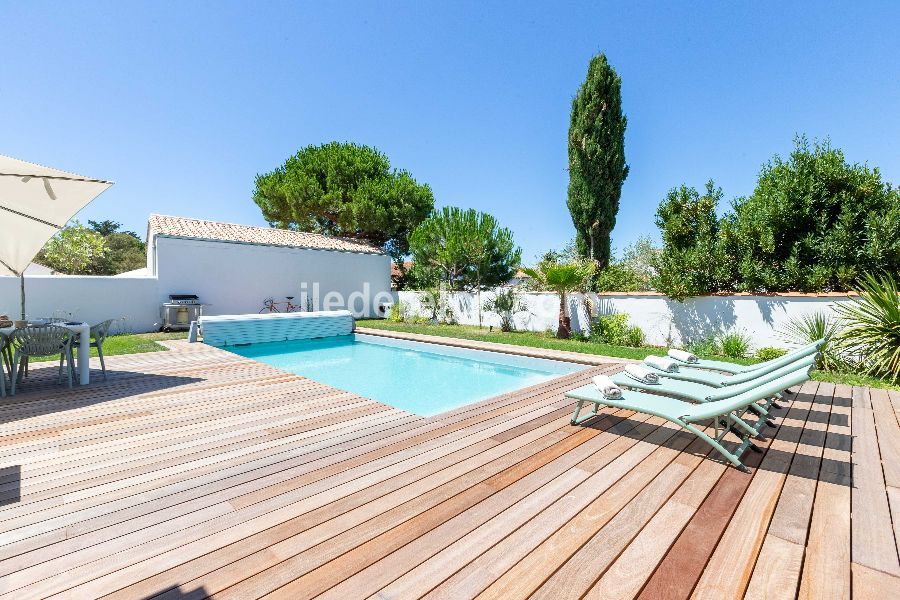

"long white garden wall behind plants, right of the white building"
[395, 291, 849, 348]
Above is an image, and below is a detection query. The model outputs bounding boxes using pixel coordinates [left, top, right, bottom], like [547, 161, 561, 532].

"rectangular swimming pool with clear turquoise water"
[225, 333, 586, 416]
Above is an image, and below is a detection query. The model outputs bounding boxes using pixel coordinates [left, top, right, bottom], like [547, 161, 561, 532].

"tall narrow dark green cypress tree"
[567, 54, 628, 267]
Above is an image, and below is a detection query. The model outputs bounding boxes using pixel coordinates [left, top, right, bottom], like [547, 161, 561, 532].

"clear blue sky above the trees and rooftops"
[0, 0, 900, 260]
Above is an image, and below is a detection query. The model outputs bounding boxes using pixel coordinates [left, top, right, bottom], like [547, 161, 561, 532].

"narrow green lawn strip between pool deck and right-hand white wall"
[357, 319, 900, 389]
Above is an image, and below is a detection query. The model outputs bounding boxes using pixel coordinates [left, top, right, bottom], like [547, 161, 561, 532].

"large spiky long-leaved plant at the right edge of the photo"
[836, 274, 900, 383]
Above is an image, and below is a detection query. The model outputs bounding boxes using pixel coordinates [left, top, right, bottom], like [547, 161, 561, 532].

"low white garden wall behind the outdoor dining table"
[0, 275, 159, 332]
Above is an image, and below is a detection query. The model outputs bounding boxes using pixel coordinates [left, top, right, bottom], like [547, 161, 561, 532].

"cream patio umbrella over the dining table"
[0, 155, 112, 319]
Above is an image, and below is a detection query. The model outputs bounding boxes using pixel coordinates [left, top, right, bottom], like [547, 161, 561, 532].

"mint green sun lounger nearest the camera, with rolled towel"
[566, 368, 810, 472]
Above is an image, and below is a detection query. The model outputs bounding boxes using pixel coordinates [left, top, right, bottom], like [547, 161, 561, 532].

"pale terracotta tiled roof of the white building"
[147, 214, 383, 254]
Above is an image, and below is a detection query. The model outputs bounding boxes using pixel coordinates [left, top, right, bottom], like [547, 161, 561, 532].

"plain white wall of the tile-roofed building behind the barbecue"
[153, 236, 391, 316]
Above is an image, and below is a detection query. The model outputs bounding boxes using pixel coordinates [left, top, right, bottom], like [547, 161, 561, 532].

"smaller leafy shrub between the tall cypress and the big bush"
[653, 179, 732, 300]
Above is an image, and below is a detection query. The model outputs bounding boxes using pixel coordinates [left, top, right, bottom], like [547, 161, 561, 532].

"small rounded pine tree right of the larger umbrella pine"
[410, 206, 522, 290]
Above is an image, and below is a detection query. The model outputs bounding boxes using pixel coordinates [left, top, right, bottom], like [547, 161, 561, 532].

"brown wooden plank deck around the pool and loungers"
[0, 343, 900, 600]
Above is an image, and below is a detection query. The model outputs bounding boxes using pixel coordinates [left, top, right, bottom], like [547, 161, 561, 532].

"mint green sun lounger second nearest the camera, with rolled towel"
[612, 354, 817, 417]
